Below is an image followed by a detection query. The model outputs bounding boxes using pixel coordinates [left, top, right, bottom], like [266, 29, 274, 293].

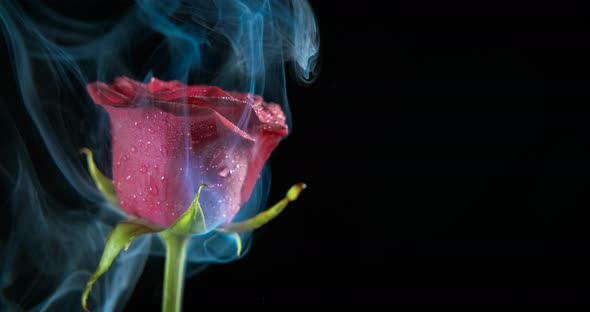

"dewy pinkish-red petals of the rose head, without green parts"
[87, 77, 288, 228]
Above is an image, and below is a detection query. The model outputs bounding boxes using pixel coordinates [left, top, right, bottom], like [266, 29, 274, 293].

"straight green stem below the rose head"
[162, 233, 190, 312]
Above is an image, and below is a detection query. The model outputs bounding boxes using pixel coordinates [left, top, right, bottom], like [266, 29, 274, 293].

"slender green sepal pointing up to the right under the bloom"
[217, 183, 306, 234]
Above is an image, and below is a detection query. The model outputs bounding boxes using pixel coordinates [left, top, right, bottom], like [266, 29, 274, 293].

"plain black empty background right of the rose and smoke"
[3, 1, 590, 311]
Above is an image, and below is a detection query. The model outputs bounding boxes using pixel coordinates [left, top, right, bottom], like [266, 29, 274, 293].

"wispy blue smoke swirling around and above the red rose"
[0, 0, 319, 311]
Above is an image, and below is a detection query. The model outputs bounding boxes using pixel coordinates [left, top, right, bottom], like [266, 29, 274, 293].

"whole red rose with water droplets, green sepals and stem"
[80, 77, 305, 311]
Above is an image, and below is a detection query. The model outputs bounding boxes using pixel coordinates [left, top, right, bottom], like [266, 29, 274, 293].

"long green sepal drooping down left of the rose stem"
[82, 219, 163, 311]
